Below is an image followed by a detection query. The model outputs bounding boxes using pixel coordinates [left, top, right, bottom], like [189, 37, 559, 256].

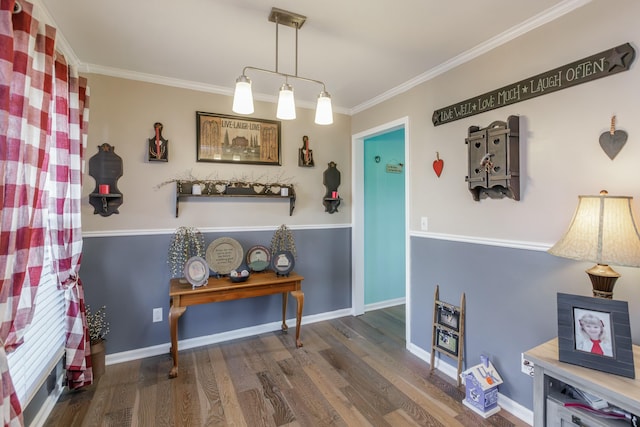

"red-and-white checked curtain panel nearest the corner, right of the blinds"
[49, 55, 93, 389]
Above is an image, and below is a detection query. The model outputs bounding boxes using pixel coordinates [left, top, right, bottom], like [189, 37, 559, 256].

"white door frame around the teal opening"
[351, 116, 411, 344]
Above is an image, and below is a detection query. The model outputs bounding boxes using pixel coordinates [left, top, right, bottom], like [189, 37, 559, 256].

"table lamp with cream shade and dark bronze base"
[548, 190, 640, 299]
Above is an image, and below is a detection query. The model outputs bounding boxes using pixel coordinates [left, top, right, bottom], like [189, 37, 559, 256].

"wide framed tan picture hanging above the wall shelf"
[196, 111, 282, 166]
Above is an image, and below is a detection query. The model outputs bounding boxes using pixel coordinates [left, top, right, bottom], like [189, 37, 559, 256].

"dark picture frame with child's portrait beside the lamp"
[557, 293, 635, 378]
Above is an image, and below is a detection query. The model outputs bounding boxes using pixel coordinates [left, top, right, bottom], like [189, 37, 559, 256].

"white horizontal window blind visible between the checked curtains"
[8, 236, 65, 408]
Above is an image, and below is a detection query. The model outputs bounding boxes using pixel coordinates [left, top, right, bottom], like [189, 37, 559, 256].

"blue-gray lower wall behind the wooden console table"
[80, 228, 351, 354]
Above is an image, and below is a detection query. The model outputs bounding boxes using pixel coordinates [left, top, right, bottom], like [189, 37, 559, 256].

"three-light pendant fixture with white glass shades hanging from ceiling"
[232, 7, 333, 125]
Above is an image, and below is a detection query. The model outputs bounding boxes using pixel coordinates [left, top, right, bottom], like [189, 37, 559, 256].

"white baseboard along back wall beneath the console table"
[105, 308, 353, 365]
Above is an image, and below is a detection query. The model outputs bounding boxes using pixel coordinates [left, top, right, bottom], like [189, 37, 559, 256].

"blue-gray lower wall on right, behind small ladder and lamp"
[410, 237, 639, 409]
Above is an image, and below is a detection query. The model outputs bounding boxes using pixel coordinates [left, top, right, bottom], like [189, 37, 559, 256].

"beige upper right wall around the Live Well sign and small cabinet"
[352, 0, 640, 244]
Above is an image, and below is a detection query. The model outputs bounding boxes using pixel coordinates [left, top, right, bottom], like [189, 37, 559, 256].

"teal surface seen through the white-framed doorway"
[364, 128, 406, 308]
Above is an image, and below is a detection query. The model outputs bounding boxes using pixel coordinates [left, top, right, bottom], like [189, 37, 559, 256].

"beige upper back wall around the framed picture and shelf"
[82, 74, 351, 232]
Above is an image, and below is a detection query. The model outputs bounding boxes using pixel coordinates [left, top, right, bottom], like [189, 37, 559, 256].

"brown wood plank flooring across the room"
[45, 306, 527, 427]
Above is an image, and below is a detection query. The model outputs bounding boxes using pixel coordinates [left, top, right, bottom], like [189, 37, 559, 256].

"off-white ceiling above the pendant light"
[40, 0, 591, 114]
